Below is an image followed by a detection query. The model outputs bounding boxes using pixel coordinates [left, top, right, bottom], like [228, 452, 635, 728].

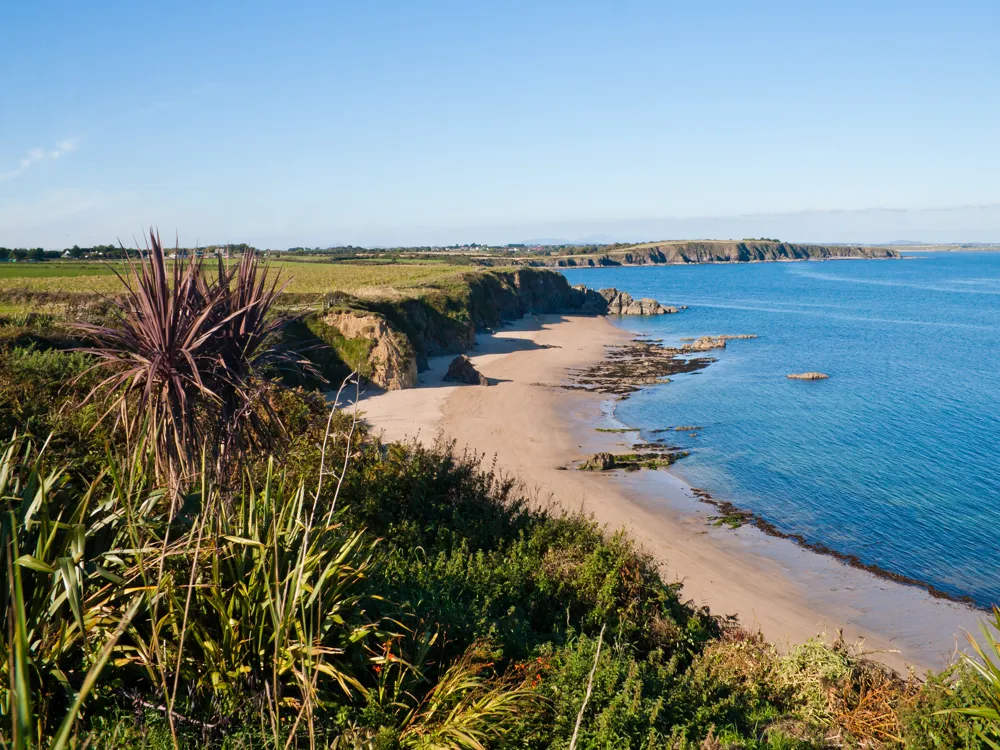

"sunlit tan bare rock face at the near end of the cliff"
[324, 311, 417, 391]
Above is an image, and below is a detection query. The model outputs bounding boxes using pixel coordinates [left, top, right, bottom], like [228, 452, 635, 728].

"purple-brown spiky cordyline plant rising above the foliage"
[74, 229, 290, 489]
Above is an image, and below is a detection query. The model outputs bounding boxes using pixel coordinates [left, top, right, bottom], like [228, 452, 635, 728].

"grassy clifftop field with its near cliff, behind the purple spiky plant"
[0, 259, 598, 387]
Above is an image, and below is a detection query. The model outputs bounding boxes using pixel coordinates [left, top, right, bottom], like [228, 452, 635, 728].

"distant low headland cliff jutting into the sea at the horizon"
[557, 241, 900, 266]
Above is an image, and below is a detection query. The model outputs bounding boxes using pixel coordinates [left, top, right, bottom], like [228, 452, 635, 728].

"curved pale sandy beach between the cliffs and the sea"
[361, 315, 983, 674]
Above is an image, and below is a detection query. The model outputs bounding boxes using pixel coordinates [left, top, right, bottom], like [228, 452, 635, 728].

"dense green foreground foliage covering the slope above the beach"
[0, 286, 1000, 750]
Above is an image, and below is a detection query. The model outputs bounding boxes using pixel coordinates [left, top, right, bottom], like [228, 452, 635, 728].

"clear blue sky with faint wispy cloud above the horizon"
[0, 0, 1000, 247]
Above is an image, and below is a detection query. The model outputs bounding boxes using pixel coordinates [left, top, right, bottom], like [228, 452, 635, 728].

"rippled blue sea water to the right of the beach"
[565, 252, 1000, 605]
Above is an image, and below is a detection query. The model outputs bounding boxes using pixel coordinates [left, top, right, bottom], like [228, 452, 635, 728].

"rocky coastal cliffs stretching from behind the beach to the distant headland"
[286, 240, 900, 390]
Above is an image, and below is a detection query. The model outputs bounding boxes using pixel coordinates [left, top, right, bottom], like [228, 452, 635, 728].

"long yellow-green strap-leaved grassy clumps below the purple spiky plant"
[0, 430, 545, 750]
